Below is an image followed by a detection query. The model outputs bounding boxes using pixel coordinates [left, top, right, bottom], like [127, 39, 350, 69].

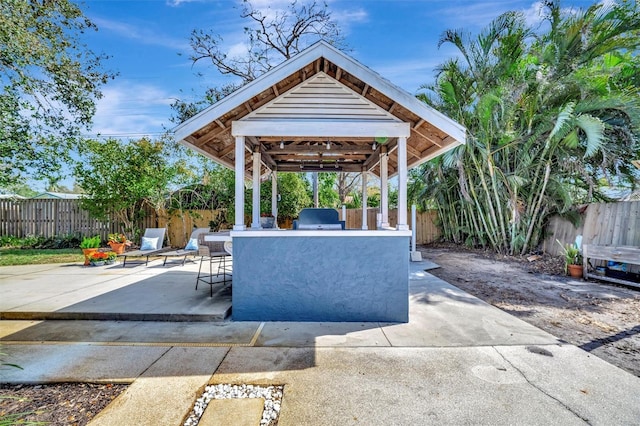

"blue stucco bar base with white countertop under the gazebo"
[231, 230, 411, 322]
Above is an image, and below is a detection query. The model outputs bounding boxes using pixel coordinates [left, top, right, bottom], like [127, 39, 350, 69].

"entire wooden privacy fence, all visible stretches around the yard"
[5, 199, 640, 255]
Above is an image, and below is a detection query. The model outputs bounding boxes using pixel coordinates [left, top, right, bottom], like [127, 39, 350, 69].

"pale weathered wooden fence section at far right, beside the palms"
[542, 201, 640, 255]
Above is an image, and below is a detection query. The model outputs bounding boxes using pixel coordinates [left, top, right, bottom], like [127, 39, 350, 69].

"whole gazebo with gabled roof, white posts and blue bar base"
[174, 41, 465, 321]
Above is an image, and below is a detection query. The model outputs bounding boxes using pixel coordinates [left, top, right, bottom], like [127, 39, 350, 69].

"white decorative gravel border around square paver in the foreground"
[184, 384, 284, 426]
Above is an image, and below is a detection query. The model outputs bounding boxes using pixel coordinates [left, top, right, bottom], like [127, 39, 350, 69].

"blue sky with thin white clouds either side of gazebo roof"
[82, 0, 594, 138]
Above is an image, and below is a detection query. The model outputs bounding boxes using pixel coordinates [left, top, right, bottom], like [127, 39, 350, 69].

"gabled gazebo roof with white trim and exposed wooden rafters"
[174, 41, 465, 176]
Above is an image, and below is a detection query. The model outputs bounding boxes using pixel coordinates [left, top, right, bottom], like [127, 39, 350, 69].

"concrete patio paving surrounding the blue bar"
[0, 261, 640, 425]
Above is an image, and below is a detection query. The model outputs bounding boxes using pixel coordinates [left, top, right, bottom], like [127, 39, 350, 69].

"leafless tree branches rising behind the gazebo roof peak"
[190, 0, 343, 84]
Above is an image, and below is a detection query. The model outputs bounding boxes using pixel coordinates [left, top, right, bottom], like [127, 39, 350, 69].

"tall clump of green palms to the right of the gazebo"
[414, 1, 640, 254]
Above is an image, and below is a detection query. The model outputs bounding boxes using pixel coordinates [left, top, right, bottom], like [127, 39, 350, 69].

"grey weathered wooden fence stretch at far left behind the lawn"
[0, 199, 155, 240]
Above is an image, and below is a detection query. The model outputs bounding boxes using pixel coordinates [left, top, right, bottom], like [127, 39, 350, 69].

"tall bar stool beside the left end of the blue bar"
[196, 232, 231, 297]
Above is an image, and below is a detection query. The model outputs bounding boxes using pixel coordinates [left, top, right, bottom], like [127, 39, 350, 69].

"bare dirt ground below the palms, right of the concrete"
[420, 246, 640, 377]
